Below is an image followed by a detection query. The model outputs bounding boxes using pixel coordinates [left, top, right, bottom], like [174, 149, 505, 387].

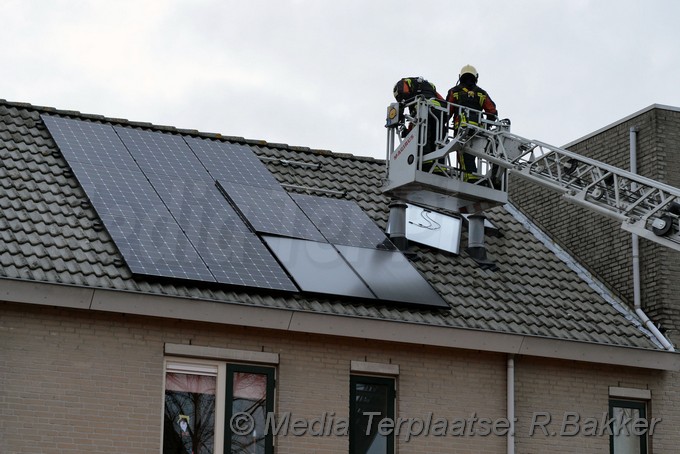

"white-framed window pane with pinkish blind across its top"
[163, 372, 217, 454]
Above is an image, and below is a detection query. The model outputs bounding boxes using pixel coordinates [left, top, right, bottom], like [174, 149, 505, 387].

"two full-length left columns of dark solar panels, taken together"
[43, 116, 297, 291]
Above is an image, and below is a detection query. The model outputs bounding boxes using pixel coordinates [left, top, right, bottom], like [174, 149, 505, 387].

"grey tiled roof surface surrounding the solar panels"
[0, 101, 658, 349]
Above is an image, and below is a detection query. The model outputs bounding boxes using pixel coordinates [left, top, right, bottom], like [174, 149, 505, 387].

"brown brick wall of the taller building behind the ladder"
[510, 109, 680, 342]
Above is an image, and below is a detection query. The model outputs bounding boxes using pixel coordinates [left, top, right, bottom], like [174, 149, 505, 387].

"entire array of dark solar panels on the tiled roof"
[42, 115, 446, 307]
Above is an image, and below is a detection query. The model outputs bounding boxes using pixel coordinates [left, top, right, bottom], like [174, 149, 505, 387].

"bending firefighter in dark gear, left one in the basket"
[394, 77, 448, 171]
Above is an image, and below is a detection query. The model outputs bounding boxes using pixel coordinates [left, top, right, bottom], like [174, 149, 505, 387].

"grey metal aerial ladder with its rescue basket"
[382, 96, 680, 251]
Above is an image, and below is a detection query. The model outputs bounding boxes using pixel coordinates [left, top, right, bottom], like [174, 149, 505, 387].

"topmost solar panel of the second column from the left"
[114, 126, 210, 180]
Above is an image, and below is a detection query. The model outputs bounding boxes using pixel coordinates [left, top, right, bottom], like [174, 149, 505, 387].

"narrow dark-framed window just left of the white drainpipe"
[349, 375, 395, 454]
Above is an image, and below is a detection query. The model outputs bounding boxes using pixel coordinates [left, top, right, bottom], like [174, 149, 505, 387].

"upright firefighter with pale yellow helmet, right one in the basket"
[446, 65, 498, 182]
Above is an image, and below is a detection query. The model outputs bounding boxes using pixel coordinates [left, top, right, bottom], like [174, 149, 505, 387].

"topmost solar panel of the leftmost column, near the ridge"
[42, 115, 139, 171]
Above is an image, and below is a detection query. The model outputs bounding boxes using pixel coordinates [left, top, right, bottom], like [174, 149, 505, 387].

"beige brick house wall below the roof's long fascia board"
[0, 303, 680, 454]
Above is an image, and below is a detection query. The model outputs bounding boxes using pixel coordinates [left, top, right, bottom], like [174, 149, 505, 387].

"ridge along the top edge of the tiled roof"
[0, 98, 385, 163]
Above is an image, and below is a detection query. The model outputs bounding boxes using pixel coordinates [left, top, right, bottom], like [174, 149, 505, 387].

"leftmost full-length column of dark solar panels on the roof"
[43, 116, 211, 280]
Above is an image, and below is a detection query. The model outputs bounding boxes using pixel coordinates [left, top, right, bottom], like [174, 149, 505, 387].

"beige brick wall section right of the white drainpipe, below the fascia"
[515, 357, 680, 454]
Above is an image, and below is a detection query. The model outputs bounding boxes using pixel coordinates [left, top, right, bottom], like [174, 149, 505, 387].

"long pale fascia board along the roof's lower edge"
[0, 280, 680, 371]
